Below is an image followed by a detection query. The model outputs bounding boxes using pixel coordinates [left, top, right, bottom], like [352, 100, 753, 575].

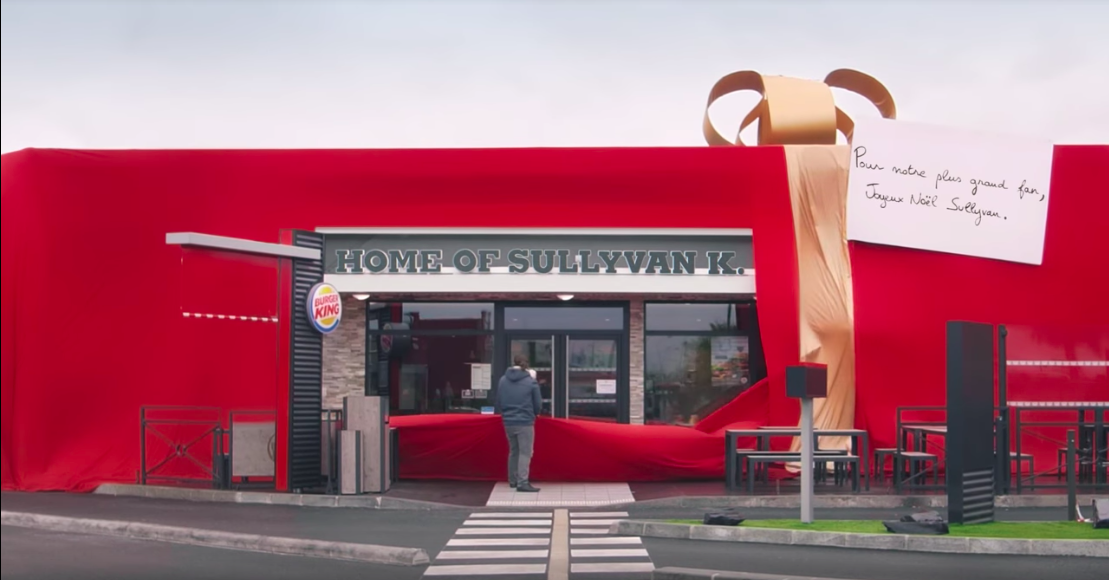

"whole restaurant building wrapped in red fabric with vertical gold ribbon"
[0, 146, 1109, 490]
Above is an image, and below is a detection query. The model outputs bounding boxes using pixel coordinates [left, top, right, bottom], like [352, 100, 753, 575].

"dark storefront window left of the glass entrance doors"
[367, 303, 494, 415]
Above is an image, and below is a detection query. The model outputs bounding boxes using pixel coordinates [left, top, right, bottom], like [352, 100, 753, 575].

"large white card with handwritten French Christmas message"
[847, 119, 1055, 265]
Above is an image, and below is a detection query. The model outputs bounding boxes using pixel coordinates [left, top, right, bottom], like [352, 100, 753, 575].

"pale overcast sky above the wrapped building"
[0, 0, 1109, 152]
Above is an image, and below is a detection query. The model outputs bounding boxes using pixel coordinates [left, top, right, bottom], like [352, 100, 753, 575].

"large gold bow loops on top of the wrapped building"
[702, 69, 897, 145]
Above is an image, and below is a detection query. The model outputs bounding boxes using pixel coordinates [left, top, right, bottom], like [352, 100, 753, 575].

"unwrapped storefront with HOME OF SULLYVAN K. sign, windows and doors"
[317, 227, 765, 425]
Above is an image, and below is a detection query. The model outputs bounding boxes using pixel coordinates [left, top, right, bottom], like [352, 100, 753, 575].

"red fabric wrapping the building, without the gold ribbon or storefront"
[2, 147, 1109, 490]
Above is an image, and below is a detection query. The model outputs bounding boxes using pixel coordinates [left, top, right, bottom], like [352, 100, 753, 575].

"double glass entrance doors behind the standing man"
[506, 334, 623, 423]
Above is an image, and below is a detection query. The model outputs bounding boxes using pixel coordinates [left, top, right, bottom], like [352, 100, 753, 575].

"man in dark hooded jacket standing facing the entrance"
[495, 355, 543, 492]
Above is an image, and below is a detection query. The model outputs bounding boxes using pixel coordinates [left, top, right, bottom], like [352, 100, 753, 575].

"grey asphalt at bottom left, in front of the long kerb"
[0, 528, 424, 580]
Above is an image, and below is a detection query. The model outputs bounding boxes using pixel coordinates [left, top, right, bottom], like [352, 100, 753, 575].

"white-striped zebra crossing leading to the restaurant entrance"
[424, 510, 654, 580]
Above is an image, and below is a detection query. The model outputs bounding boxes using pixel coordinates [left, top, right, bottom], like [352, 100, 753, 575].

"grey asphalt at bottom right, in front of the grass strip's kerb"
[643, 538, 1106, 580]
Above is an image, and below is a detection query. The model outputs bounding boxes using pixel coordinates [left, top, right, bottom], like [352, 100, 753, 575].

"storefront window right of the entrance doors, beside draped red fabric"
[644, 304, 761, 425]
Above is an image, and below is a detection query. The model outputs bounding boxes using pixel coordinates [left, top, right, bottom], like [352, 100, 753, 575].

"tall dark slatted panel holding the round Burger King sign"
[288, 232, 324, 489]
